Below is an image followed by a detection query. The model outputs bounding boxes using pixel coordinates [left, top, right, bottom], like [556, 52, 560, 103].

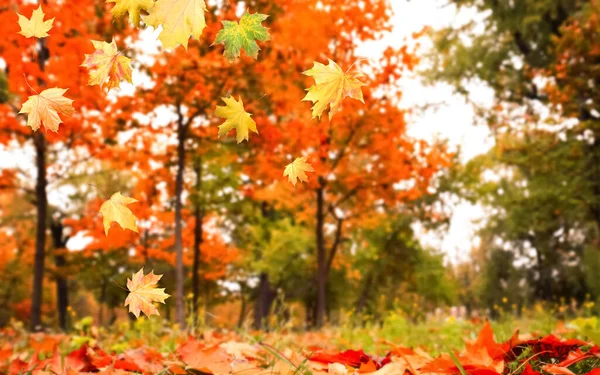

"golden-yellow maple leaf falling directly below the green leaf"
[215, 96, 258, 143]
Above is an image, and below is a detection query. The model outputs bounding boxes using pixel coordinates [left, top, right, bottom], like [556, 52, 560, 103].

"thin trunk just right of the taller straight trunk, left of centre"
[192, 157, 204, 325]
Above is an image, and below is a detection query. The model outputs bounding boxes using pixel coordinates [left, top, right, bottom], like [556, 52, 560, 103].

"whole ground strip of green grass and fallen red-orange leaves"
[0, 315, 600, 375]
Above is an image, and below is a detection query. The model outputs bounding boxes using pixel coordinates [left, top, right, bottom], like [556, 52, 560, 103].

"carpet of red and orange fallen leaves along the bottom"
[0, 323, 600, 375]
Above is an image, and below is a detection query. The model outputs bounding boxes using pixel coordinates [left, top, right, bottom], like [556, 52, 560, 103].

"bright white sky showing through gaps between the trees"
[0, 0, 493, 263]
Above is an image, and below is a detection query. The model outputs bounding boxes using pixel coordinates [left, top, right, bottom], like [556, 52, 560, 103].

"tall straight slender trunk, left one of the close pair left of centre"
[175, 112, 186, 329]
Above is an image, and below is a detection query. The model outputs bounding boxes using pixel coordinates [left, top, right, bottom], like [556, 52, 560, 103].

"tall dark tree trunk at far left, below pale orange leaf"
[30, 39, 48, 331]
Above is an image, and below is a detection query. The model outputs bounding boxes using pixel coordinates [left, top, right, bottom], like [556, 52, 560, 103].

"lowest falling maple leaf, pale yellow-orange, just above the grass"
[125, 267, 169, 318]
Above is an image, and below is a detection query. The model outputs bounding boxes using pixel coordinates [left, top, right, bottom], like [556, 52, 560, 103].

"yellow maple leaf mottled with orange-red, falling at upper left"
[81, 40, 132, 90]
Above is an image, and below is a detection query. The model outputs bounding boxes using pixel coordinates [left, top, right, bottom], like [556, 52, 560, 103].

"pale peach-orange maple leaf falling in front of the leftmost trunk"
[19, 87, 75, 132]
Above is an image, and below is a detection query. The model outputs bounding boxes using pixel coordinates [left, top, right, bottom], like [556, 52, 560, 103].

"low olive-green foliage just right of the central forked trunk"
[353, 216, 456, 315]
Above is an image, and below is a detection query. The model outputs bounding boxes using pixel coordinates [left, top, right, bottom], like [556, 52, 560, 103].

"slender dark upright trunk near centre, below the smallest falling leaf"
[314, 183, 327, 328]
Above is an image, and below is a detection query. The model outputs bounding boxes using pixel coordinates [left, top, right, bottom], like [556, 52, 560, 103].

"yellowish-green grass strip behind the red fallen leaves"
[5, 307, 600, 356]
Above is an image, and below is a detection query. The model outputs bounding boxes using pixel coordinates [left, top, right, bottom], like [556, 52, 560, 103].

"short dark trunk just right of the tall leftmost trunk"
[50, 219, 69, 331]
